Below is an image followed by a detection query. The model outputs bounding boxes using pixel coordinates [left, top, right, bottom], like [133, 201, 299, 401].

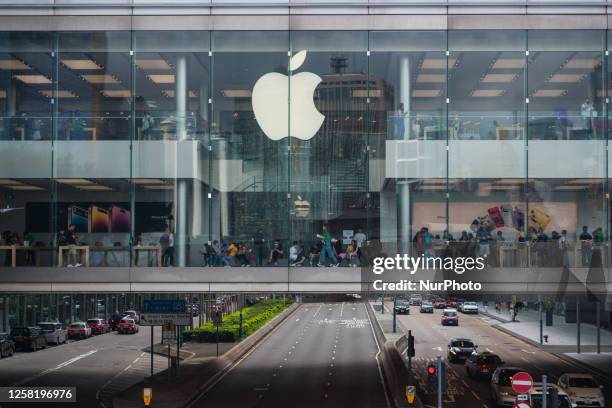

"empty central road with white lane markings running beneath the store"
[194, 303, 388, 408]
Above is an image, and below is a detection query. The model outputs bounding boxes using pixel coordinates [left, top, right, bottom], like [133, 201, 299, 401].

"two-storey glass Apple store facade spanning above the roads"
[0, 1, 612, 318]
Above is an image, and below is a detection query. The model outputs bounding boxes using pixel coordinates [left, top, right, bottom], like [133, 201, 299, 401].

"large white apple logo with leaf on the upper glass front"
[251, 50, 325, 140]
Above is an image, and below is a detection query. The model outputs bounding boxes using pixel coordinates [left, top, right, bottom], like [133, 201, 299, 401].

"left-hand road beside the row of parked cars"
[0, 327, 168, 408]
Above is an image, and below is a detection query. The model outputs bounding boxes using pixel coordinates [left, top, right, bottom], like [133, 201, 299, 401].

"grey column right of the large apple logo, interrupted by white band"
[396, 56, 412, 254]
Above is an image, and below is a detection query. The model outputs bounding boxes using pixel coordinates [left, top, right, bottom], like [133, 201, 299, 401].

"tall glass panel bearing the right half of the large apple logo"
[290, 31, 370, 266]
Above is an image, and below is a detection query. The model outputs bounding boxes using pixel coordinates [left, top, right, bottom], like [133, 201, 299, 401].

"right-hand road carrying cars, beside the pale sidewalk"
[396, 306, 612, 408]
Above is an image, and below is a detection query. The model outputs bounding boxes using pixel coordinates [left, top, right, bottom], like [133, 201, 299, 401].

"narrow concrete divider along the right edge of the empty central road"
[366, 302, 423, 408]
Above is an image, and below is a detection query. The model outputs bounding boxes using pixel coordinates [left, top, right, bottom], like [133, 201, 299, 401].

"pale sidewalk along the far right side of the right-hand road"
[479, 304, 612, 376]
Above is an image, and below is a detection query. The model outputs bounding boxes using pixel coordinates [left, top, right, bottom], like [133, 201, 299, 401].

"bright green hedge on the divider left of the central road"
[184, 300, 292, 343]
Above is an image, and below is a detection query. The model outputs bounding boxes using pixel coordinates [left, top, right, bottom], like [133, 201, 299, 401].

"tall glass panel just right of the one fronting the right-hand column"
[448, 31, 527, 267]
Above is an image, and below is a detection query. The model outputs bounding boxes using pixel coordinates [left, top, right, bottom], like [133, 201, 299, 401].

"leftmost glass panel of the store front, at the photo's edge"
[0, 33, 54, 266]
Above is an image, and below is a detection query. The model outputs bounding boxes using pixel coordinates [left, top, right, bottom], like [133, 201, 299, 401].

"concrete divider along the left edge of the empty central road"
[113, 303, 300, 408]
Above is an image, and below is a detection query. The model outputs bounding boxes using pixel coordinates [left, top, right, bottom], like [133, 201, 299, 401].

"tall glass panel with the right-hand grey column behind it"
[369, 31, 448, 262]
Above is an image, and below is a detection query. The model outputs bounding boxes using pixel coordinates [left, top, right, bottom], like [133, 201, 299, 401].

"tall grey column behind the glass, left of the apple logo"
[174, 56, 188, 266]
